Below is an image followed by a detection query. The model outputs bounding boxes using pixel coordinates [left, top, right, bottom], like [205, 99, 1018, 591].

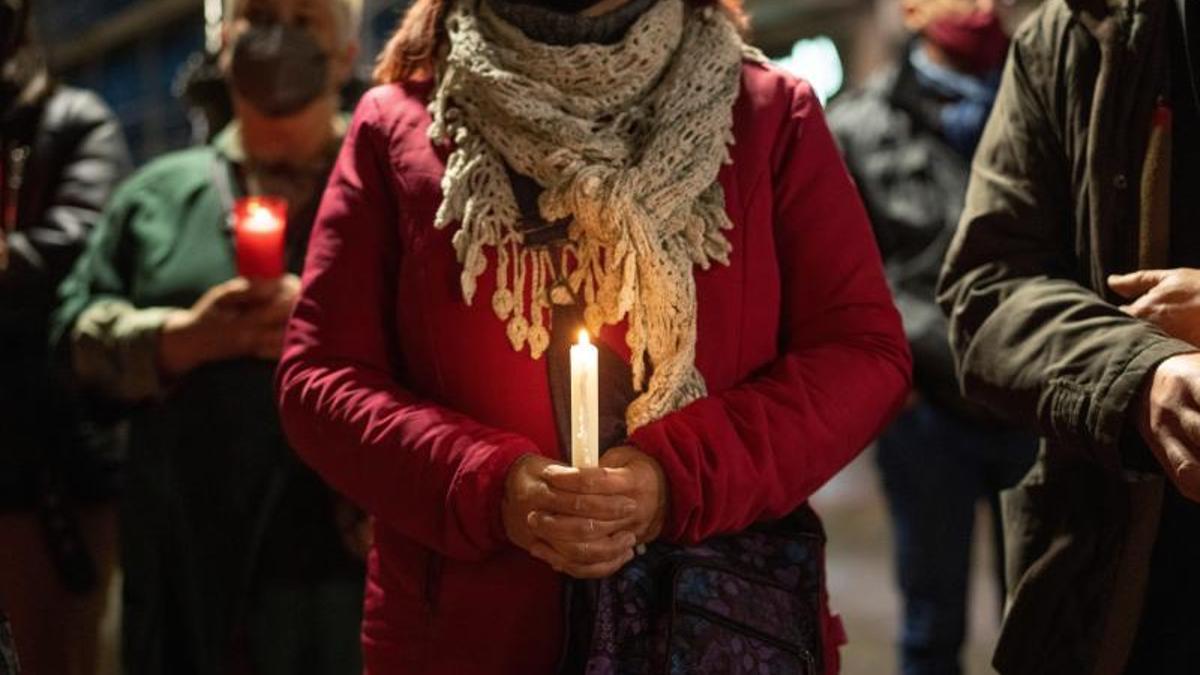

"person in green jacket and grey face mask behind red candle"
[53, 0, 367, 675]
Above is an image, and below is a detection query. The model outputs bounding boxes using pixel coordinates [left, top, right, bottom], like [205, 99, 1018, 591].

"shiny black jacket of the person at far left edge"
[0, 86, 131, 509]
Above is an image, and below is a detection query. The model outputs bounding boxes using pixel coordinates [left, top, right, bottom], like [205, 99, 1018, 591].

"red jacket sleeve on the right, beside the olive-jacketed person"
[631, 79, 911, 542]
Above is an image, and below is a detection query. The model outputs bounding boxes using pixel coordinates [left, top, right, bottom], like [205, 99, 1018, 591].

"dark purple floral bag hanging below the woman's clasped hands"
[571, 507, 824, 675]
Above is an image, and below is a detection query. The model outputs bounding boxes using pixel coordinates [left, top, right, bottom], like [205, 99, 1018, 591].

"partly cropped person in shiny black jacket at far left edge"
[0, 0, 131, 675]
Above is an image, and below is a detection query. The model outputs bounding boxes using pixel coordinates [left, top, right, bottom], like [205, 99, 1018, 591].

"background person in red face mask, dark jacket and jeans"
[829, 0, 1036, 675]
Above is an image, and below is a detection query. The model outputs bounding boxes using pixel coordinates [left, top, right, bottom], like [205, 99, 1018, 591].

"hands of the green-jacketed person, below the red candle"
[158, 276, 299, 377]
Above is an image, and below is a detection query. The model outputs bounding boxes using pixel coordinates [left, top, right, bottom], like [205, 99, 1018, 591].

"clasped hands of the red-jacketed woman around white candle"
[502, 455, 637, 579]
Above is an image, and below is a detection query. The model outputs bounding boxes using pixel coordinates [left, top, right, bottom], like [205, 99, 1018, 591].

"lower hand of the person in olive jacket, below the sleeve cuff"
[1138, 353, 1200, 502]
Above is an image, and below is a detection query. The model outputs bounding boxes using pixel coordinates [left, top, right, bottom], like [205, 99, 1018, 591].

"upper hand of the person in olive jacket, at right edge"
[1109, 268, 1200, 347]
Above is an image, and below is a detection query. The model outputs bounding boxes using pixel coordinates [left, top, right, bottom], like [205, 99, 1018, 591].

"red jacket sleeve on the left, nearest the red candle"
[277, 95, 538, 560]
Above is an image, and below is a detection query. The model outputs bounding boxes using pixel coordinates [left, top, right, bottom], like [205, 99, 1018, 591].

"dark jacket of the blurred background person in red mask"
[829, 51, 985, 419]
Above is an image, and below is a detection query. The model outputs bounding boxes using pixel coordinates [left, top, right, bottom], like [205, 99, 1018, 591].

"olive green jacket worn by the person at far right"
[940, 0, 1194, 675]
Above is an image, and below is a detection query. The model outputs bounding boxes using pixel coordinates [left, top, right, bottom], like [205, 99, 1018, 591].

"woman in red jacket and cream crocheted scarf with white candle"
[278, 0, 910, 675]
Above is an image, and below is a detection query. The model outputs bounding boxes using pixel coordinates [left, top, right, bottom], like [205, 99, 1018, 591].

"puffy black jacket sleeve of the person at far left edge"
[0, 91, 130, 322]
